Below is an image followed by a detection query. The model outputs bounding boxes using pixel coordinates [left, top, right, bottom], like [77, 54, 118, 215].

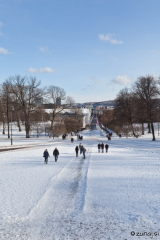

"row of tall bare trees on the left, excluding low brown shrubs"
[0, 75, 80, 138]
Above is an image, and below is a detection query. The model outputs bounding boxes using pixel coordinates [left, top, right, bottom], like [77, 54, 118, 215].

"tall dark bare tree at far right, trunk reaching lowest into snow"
[133, 75, 160, 141]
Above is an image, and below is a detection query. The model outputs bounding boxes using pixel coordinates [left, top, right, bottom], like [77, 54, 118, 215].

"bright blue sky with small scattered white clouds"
[0, 0, 160, 102]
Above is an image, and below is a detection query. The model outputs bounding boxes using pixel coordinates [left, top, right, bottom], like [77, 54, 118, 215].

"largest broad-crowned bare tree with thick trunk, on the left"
[8, 75, 43, 138]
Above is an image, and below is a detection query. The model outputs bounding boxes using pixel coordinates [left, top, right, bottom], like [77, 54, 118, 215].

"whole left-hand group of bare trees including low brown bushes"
[0, 75, 82, 138]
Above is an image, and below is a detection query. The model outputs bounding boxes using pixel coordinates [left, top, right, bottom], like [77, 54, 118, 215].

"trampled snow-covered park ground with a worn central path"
[0, 125, 160, 240]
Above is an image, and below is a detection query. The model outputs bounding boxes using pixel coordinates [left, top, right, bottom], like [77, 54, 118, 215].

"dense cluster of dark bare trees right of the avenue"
[100, 75, 160, 141]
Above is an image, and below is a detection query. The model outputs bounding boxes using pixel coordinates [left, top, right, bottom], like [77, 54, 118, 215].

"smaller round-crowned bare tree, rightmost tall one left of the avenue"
[47, 86, 66, 129]
